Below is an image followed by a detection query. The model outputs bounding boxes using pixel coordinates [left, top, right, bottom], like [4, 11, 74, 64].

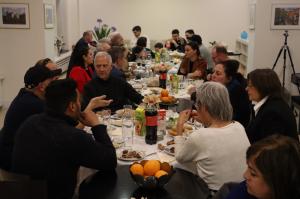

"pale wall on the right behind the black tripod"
[253, 0, 300, 94]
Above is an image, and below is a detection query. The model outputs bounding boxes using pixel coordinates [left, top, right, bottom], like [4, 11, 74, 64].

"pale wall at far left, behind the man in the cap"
[0, 0, 45, 107]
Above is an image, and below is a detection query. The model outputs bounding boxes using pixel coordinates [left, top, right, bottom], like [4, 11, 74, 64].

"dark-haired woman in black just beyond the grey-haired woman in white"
[211, 60, 251, 127]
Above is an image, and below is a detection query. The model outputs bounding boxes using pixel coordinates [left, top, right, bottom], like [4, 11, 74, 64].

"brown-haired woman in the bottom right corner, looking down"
[226, 135, 300, 199]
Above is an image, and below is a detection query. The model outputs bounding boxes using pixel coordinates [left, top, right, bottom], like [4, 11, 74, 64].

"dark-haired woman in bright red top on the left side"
[68, 48, 94, 93]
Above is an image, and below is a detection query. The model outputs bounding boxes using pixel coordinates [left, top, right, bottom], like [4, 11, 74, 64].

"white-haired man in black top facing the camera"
[83, 52, 143, 112]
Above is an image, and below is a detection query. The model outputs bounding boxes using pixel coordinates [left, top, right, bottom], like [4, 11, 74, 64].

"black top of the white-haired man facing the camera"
[82, 75, 143, 112]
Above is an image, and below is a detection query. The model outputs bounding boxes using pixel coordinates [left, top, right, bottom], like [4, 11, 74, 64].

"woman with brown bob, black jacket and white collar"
[246, 69, 298, 143]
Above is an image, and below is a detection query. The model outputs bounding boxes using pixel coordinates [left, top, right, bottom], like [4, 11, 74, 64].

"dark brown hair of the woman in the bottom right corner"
[246, 135, 300, 199]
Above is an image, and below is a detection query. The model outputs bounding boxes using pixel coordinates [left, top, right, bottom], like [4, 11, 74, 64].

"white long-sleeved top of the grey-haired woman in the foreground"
[175, 122, 250, 190]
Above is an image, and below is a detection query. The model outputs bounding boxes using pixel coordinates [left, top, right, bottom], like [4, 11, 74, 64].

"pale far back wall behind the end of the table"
[79, 0, 248, 49]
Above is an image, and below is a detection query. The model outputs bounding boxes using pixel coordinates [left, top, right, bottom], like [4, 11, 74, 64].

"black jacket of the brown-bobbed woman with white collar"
[246, 97, 298, 143]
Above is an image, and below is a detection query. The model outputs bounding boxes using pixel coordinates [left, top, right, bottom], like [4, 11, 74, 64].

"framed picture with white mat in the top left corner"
[0, 3, 30, 28]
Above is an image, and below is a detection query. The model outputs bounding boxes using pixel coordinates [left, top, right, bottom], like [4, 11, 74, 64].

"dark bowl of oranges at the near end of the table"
[129, 160, 175, 189]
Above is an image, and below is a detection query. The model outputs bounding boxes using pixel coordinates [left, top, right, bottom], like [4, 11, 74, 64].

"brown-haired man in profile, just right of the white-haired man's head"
[108, 46, 128, 81]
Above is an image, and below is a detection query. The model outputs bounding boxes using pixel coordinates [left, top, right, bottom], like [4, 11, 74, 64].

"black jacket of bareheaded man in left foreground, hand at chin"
[12, 112, 117, 199]
